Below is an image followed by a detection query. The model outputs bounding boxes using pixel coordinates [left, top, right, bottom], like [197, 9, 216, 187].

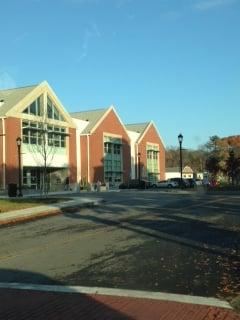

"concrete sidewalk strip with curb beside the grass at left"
[0, 197, 103, 225]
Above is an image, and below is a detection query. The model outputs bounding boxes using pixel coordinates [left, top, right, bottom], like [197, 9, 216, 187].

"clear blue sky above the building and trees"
[0, 0, 240, 148]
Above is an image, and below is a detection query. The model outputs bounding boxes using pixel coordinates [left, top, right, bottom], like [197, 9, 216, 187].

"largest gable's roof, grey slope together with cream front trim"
[0, 81, 75, 128]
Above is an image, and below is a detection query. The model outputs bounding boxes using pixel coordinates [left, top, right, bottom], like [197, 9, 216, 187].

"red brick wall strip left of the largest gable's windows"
[5, 118, 21, 185]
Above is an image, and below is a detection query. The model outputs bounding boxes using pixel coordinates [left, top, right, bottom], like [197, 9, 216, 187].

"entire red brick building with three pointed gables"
[0, 81, 165, 190]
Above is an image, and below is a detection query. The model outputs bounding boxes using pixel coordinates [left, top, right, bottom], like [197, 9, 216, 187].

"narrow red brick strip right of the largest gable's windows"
[68, 128, 77, 183]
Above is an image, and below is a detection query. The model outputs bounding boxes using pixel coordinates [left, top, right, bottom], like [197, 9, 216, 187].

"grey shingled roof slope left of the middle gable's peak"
[70, 108, 109, 134]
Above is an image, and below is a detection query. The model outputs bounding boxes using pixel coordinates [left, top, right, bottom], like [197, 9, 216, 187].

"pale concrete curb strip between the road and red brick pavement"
[0, 282, 232, 309]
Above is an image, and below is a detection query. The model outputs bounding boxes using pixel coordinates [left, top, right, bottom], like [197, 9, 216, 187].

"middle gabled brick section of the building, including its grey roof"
[71, 107, 131, 188]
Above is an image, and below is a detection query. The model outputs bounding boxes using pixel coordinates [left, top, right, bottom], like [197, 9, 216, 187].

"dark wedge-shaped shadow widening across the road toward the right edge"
[64, 212, 240, 258]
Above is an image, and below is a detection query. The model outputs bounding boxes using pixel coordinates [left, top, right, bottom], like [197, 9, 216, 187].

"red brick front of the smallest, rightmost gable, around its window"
[136, 125, 165, 180]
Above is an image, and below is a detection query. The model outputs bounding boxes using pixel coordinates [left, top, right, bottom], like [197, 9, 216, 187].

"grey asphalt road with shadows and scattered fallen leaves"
[0, 190, 240, 298]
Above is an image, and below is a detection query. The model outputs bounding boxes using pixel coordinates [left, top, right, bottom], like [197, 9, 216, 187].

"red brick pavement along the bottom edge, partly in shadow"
[0, 289, 240, 320]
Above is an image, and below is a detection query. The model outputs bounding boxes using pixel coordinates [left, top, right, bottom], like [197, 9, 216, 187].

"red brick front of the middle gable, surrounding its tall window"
[87, 110, 131, 182]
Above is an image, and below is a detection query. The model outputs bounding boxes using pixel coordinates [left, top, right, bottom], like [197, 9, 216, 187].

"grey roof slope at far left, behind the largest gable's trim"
[0, 85, 38, 117]
